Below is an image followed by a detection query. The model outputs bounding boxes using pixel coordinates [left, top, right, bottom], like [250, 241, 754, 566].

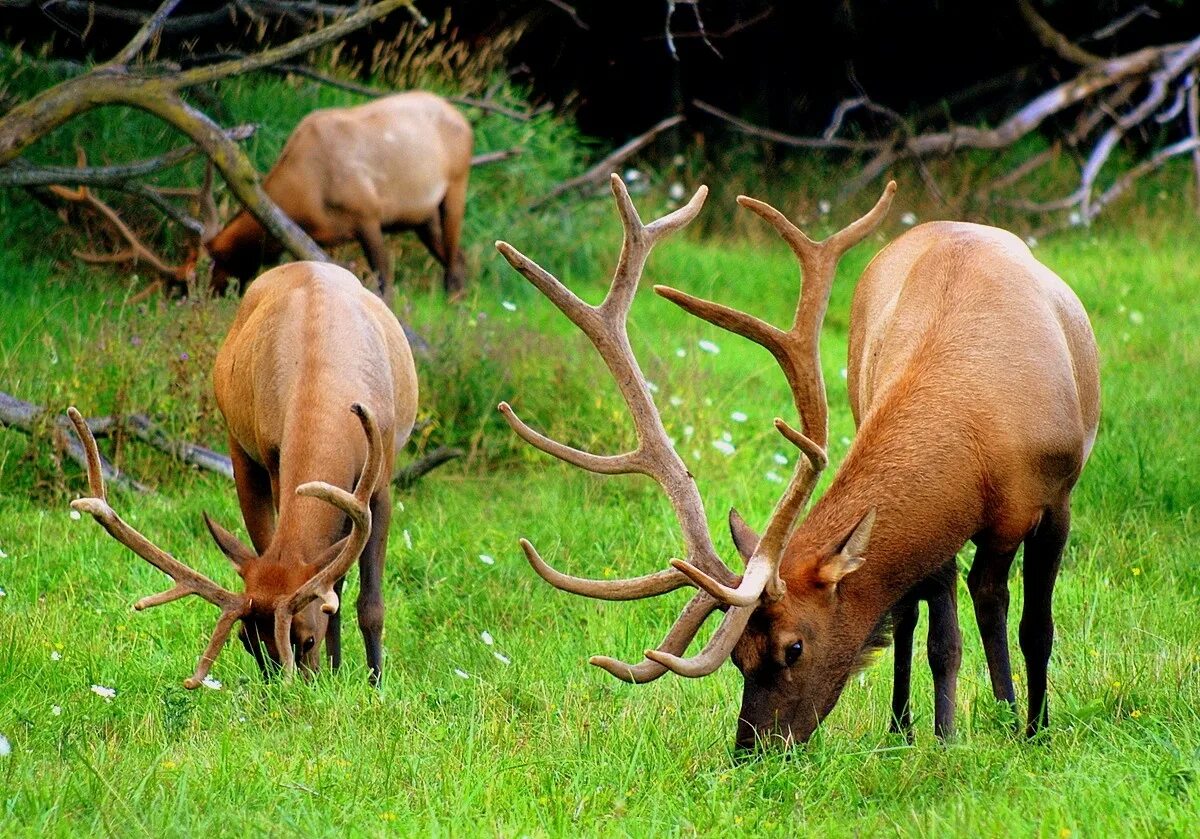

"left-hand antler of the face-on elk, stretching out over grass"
[67, 407, 250, 690]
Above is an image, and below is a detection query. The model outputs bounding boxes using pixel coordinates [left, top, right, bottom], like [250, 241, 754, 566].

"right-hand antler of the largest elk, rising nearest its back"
[654, 181, 896, 619]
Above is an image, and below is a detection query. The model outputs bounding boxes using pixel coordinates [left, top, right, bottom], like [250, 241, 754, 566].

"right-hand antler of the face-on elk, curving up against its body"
[275, 402, 384, 676]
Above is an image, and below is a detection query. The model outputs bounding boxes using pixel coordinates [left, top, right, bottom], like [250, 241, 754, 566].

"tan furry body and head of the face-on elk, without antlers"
[204, 262, 416, 669]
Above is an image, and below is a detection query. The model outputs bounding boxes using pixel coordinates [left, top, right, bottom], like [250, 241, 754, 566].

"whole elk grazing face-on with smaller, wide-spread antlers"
[71, 262, 416, 688]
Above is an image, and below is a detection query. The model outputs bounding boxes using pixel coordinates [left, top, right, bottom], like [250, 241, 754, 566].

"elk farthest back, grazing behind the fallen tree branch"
[204, 91, 474, 300]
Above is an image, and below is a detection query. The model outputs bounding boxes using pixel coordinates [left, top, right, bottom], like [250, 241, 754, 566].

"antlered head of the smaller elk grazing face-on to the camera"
[67, 403, 384, 689]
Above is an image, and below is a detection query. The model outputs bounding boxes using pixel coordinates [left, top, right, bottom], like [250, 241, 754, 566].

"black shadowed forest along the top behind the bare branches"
[0, 0, 1200, 140]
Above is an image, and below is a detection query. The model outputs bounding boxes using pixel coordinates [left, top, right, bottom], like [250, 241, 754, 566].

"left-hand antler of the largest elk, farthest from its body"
[496, 174, 737, 682]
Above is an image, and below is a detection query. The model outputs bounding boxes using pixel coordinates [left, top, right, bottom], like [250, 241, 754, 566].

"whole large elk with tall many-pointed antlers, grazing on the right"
[497, 178, 1099, 748]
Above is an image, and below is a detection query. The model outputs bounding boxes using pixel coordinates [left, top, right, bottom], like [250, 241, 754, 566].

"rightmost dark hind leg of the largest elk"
[1020, 504, 1070, 737]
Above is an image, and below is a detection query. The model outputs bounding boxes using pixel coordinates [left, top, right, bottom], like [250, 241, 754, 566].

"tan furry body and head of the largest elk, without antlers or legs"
[734, 222, 1099, 744]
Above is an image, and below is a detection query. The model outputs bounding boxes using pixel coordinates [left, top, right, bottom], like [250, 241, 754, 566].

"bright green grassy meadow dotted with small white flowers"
[0, 57, 1200, 838]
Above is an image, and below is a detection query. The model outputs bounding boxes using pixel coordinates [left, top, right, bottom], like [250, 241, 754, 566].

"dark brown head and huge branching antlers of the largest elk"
[497, 175, 895, 747]
